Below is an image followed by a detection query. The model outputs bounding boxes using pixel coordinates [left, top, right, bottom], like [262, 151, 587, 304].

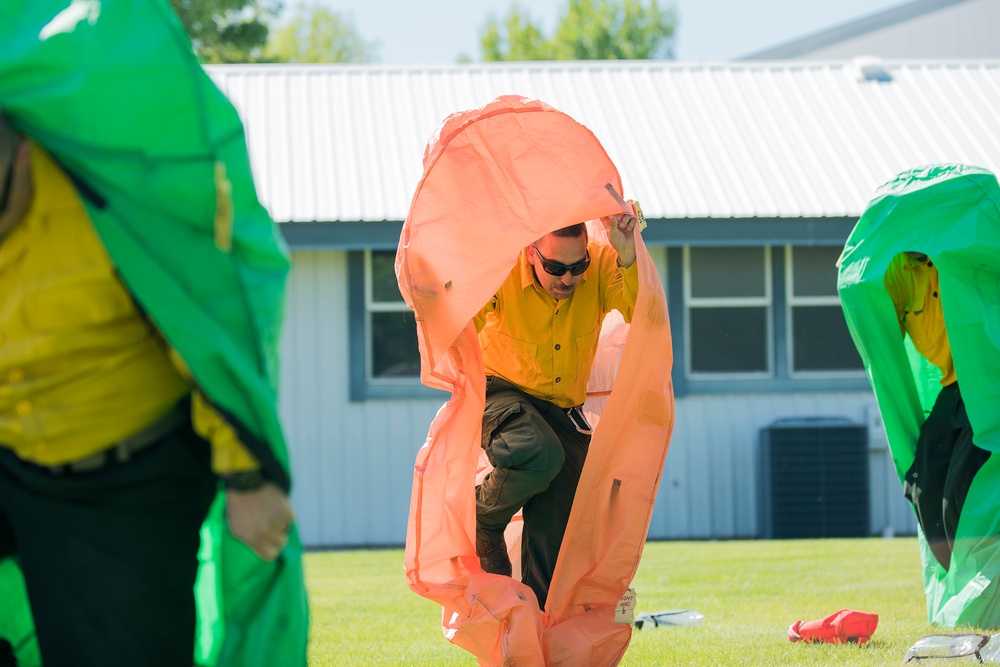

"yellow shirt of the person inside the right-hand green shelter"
[885, 253, 957, 386]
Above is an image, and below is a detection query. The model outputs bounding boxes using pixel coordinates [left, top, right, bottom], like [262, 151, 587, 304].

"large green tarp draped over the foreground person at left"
[0, 0, 308, 667]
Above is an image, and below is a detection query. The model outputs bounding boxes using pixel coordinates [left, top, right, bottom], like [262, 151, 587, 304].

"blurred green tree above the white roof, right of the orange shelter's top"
[480, 0, 677, 61]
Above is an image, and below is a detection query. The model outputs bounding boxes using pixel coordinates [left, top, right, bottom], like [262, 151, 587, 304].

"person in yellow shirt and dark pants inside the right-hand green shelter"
[885, 252, 990, 569]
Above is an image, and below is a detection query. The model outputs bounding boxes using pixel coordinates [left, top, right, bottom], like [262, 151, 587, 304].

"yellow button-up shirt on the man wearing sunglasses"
[475, 242, 639, 408]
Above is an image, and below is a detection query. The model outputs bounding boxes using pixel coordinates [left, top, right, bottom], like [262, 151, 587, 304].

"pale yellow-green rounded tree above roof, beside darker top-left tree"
[264, 4, 377, 63]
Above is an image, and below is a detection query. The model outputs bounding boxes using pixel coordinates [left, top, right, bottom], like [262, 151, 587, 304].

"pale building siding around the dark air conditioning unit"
[649, 392, 916, 539]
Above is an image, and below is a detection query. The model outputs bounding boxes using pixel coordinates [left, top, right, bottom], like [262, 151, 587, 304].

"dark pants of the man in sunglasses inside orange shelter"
[476, 377, 590, 609]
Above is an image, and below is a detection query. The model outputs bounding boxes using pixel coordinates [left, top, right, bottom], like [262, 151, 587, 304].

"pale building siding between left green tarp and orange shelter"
[280, 250, 440, 546]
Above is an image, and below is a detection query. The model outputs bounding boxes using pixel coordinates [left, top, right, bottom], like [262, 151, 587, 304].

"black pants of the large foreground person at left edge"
[0, 425, 217, 667]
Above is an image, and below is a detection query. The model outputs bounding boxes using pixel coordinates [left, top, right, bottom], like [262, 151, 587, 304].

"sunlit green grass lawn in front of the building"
[306, 538, 953, 667]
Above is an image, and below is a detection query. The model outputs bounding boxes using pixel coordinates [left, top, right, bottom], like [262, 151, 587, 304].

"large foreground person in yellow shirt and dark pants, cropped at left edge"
[0, 115, 292, 667]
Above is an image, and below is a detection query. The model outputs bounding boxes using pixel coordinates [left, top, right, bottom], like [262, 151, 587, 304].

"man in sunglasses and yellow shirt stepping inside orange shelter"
[476, 210, 638, 609]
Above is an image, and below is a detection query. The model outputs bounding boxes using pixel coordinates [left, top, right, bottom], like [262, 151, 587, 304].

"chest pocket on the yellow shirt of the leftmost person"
[23, 279, 137, 332]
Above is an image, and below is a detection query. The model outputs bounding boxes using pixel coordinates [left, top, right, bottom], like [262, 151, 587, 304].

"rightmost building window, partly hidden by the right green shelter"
[785, 246, 864, 376]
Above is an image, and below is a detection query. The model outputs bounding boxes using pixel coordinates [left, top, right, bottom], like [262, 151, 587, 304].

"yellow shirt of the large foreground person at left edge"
[0, 144, 258, 472]
